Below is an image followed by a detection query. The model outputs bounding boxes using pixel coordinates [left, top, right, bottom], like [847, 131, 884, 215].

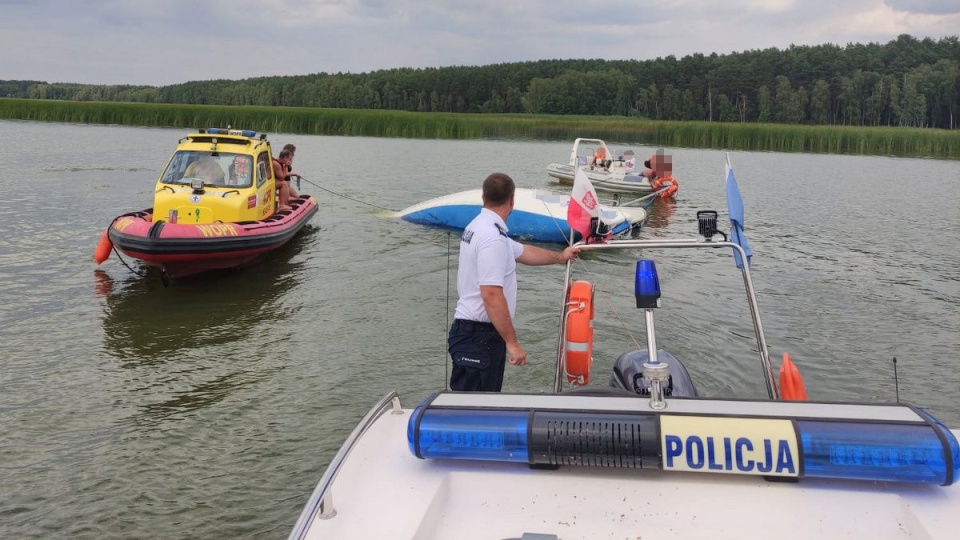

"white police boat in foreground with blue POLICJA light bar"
[289, 162, 960, 540]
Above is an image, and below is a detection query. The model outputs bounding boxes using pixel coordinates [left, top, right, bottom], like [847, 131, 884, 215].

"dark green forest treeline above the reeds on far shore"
[0, 35, 960, 129]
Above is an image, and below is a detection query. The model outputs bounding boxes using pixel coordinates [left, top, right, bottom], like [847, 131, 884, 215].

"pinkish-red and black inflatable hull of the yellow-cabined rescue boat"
[108, 195, 318, 278]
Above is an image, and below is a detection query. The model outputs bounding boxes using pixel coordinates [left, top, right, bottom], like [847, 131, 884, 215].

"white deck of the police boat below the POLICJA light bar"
[298, 409, 960, 540]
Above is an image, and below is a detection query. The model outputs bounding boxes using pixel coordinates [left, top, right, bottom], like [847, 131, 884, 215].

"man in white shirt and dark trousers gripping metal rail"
[447, 173, 580, 392]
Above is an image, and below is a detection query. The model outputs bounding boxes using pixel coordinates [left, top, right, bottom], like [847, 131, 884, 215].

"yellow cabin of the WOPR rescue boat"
[153, 128, 277, 224]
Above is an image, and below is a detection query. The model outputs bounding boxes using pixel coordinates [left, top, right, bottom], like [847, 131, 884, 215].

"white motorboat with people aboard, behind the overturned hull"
[547, 138, 677, 196]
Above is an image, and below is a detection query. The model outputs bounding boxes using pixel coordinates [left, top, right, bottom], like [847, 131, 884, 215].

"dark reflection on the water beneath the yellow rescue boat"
[95, 227, 318, 432]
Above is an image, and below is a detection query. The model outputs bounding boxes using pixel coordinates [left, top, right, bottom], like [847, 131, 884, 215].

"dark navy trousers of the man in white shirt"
[447, 319, 507, 392]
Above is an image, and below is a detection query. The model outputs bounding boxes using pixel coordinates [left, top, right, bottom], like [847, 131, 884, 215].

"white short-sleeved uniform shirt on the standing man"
[454, 208, 523, 322]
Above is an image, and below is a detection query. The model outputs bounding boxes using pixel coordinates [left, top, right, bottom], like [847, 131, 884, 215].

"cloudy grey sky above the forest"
[0, 0, 960, 86]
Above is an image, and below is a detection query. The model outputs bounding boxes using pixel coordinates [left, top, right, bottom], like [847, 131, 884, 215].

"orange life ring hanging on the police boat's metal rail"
[563, 281, 593, 386]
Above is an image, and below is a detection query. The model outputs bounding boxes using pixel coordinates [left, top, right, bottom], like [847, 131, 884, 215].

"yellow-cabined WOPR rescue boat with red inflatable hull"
[94, 128, 317, 279]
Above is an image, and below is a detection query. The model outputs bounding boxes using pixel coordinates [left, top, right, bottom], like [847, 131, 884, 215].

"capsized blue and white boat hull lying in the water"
[394, 188, 647, 244]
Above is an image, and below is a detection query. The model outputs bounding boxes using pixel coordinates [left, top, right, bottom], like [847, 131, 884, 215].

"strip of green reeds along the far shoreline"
[0, 99, 960, 159]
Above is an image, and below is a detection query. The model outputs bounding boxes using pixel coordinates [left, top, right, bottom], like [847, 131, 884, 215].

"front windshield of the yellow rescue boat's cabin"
[160, 150, 253, 188]
